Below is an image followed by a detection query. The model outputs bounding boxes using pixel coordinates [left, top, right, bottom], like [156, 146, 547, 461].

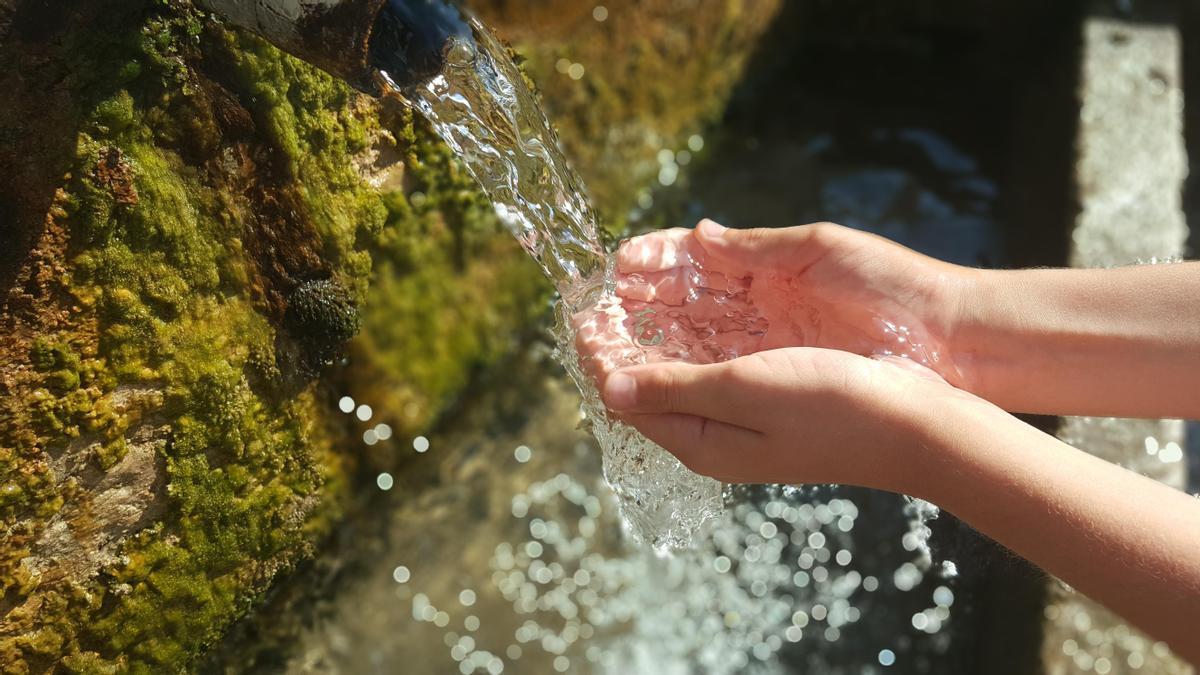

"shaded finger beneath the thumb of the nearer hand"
[628, 413, 763, 483]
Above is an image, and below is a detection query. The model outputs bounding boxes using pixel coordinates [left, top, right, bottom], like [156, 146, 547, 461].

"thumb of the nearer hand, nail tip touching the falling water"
[601, 362, 761, 429]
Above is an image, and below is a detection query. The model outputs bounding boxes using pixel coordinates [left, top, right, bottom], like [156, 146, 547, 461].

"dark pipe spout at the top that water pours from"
[198, 0, 472, 95]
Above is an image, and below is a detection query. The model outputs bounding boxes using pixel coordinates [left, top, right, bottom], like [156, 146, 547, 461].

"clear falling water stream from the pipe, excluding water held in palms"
[369, 22, 722, 550]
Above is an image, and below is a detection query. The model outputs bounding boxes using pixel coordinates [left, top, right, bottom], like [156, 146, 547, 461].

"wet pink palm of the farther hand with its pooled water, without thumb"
[576, 223, 955, 381]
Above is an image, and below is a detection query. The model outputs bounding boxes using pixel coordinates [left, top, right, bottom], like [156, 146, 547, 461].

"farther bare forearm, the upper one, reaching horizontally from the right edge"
[950, 263, 1200, 418]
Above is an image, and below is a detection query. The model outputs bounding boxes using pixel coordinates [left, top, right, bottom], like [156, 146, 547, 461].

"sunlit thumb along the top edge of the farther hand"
[696, 219, 840, 271]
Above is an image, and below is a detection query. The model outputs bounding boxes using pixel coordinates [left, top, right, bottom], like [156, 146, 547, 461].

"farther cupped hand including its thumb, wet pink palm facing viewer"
[617, 220, 970, 383]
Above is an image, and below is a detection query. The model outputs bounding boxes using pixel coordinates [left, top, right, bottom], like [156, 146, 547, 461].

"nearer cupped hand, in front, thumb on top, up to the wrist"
[602, 347, 973, 494]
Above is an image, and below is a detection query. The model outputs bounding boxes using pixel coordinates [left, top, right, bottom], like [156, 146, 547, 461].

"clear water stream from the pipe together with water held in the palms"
[369, 10, 940, 551]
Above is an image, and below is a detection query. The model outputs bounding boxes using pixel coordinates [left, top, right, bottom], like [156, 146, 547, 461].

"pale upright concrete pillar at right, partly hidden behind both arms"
[1042, 10, 1192, 675]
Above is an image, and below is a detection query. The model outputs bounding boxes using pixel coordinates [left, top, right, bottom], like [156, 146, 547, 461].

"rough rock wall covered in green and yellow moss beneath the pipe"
[0, 0, 774, 673]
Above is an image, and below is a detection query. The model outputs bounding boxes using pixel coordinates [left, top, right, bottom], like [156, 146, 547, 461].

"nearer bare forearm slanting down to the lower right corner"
[914, 400, 1200, 663]
